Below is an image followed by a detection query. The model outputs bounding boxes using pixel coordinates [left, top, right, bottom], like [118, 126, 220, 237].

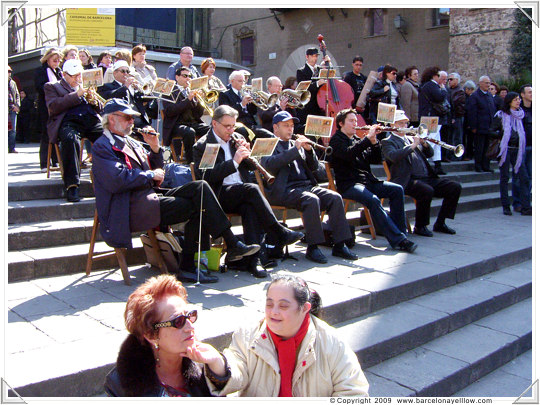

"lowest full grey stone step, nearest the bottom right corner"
[366, 298, 532, 397]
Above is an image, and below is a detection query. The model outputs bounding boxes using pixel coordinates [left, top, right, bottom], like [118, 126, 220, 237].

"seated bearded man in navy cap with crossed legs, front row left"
[92, 99, 259, 283]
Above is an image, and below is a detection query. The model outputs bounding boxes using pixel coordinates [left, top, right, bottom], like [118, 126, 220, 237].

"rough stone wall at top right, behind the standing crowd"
[449, 8, 515, 83]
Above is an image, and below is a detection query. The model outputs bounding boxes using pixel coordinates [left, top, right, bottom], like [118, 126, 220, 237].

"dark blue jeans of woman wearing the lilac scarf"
[499, 147, 531, 209]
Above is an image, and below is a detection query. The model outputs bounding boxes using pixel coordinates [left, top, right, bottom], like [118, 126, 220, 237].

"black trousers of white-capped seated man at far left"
[58, 116, 103, 188]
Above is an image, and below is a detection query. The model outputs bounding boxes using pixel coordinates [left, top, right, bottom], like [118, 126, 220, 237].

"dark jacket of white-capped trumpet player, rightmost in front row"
[381, 134, 438, 190]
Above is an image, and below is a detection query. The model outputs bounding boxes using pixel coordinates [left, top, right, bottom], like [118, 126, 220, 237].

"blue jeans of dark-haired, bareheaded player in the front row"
[343, 181, 407, 248]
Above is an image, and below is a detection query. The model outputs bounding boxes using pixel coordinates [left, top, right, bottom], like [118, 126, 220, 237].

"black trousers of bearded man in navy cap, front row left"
[159, 180, 231, 253]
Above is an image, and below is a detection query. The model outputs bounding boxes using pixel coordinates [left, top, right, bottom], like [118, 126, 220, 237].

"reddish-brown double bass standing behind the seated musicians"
[317, 34, 366, 146]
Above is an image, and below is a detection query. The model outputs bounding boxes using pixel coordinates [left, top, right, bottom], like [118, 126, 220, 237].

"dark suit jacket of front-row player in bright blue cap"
[261, 141, 319, 205]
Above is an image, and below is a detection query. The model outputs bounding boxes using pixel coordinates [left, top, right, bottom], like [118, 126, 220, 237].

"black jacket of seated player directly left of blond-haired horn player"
[163, 87, 204, 145]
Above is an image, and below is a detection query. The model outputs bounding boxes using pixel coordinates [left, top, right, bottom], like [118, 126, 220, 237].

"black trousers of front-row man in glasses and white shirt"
[219, 183, 281, 244]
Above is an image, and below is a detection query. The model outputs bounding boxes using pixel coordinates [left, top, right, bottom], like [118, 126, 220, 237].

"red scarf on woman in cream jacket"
[267, 312, 309, 397]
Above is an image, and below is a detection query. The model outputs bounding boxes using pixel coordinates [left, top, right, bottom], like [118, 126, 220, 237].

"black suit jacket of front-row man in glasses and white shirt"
[193, 129, 252, 198]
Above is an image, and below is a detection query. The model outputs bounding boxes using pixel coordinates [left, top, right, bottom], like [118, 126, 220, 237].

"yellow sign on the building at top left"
[66, 8, 115, 46]
